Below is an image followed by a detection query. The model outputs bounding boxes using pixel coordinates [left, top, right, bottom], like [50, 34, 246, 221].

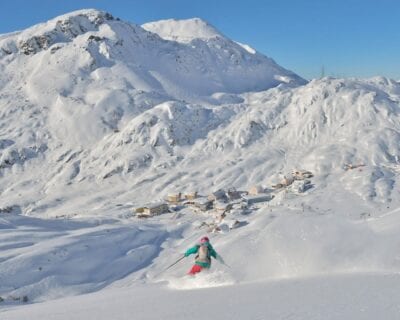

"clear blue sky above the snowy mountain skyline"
[0, 0, 400, 80]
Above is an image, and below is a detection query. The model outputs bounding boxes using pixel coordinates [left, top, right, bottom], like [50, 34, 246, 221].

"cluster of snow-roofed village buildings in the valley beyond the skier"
[134, 170, 313, 232]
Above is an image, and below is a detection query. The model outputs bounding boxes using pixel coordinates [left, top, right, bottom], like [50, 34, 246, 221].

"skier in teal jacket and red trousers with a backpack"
[185, 237, 218, 275]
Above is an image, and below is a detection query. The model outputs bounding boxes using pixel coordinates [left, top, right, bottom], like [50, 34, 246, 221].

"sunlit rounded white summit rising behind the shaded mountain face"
[142, 18, 224, 43]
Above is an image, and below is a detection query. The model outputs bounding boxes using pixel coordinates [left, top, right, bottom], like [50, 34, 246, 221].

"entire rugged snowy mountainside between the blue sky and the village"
[0, 10, 400, 220]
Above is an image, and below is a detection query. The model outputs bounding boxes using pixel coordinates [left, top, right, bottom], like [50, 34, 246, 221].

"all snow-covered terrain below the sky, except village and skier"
[0, 10, 400, 320]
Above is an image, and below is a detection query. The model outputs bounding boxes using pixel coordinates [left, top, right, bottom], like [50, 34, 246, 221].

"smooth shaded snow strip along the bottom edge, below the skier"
[1, 275, 400, 320]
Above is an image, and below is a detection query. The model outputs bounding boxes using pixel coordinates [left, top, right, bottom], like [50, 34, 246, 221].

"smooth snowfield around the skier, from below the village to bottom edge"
[0, 208, 400, 319]
